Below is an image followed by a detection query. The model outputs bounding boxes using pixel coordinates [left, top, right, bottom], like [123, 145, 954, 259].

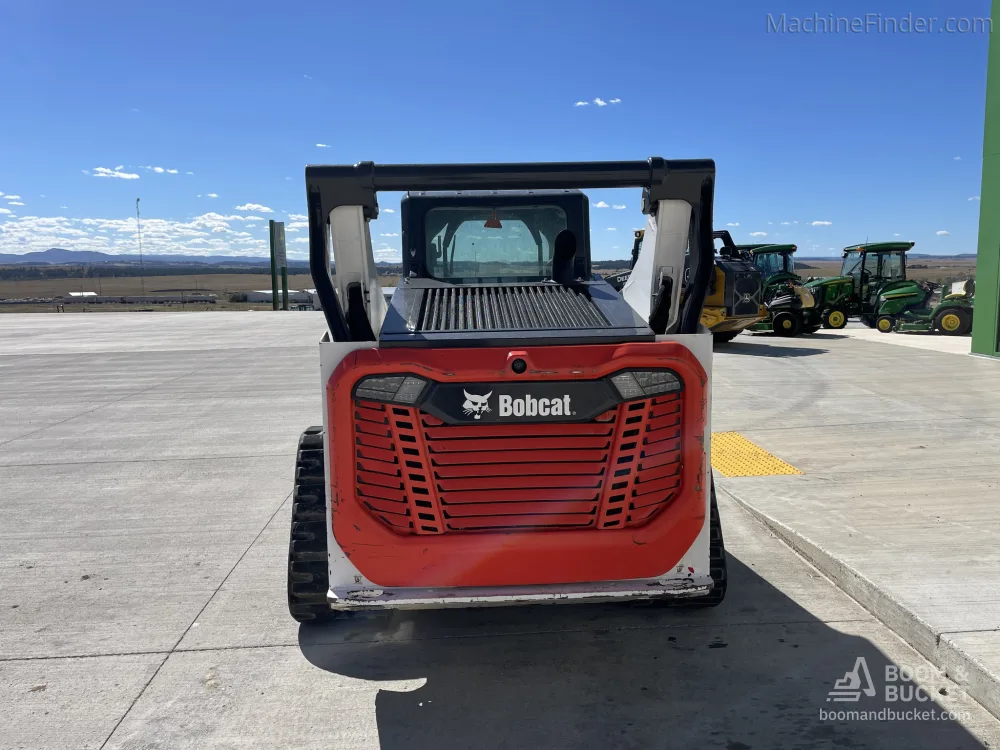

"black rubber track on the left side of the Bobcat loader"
[288, 427, 335, 622]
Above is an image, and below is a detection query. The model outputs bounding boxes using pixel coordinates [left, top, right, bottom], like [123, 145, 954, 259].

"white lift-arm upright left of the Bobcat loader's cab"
[330, 206, 389, 334]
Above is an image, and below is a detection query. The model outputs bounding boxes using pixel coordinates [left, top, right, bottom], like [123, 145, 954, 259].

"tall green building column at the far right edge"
[972, 0, 1000, 357]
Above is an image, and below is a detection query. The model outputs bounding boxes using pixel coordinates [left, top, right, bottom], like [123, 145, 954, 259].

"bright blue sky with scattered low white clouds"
[0, 0, 989, 259]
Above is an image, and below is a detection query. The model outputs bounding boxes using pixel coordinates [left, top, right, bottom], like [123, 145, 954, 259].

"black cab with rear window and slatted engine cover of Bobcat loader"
[378, 190, 654, 346]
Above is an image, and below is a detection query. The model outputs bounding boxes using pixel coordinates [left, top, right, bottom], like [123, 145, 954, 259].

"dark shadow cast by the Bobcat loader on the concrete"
[299, 556, 982, 750]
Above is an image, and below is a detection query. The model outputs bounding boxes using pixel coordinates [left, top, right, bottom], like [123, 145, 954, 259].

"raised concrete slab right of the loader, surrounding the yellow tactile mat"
[712, 331, 1000, 715]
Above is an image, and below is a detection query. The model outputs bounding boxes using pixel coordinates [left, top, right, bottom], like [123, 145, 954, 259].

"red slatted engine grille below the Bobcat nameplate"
[354, 394, 681, 534]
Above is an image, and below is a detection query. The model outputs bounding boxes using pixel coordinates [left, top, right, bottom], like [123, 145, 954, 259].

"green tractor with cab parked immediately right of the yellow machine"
[712, 230, 821, 336]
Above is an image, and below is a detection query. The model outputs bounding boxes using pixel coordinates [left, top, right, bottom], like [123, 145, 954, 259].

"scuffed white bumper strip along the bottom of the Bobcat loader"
[327, 576, 712, 612]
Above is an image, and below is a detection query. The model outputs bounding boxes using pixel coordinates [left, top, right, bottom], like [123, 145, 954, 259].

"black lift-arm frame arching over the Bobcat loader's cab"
[306, 156, 715, 341]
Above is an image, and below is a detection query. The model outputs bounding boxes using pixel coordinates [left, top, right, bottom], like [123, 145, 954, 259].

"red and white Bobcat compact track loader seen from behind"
[288, 158, 726, 621]
